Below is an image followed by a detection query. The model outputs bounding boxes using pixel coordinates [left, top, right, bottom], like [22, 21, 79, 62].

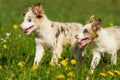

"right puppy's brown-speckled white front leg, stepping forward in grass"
[90, 52, 101, 74]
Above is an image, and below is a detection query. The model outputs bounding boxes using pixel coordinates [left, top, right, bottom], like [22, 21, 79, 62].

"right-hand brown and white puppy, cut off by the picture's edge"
[76, 16, 120, 73]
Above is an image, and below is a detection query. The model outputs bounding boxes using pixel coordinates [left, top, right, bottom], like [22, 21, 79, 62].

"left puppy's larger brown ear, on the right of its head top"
[32, 3, 44, 15]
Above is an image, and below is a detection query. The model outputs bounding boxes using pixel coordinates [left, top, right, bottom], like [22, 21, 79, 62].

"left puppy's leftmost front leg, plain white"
[34, 40, 44, 65]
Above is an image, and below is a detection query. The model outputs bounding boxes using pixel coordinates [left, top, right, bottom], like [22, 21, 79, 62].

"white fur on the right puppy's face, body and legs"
[77, 24, 120, 74]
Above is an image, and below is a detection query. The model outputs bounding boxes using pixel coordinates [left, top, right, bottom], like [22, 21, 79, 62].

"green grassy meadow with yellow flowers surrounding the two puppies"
[0, 0, 120, 80]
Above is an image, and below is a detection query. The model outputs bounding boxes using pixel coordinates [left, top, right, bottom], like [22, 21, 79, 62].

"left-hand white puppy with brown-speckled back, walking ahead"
[20, 3, 82, 65]
